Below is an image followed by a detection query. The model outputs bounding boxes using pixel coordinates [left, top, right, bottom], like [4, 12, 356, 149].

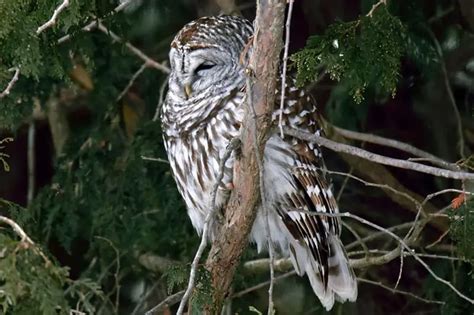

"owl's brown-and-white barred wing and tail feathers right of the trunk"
[273, 84, 357, 310]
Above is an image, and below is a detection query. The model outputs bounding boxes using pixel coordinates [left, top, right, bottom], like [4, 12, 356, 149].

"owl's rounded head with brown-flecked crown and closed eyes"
[169, 15, 253, 100]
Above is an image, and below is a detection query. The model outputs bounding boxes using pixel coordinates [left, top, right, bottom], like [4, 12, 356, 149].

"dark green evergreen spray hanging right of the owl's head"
[292, 5, 405, 103]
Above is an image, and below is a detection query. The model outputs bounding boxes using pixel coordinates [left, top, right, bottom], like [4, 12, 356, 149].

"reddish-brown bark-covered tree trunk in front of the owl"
[204, 0, 286, 314]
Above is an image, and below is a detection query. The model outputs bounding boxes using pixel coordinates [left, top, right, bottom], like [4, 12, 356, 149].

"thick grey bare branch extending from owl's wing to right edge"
[284, 127, 474, 179]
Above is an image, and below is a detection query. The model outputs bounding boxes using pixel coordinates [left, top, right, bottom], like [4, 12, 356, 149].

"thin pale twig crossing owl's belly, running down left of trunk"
[176, 139, 239, 315]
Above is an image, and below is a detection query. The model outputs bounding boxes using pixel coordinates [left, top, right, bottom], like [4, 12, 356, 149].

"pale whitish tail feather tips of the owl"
[290, 233, 357, 311]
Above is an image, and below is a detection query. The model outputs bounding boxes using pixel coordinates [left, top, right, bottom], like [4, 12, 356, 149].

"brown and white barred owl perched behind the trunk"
[161, 16, 357, 310]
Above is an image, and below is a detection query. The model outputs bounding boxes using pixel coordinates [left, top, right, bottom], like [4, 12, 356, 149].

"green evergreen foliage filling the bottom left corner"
[0, 200, 103, 315]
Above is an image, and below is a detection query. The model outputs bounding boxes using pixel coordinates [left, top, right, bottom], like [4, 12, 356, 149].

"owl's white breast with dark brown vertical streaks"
[163, 97, 243, 231]
